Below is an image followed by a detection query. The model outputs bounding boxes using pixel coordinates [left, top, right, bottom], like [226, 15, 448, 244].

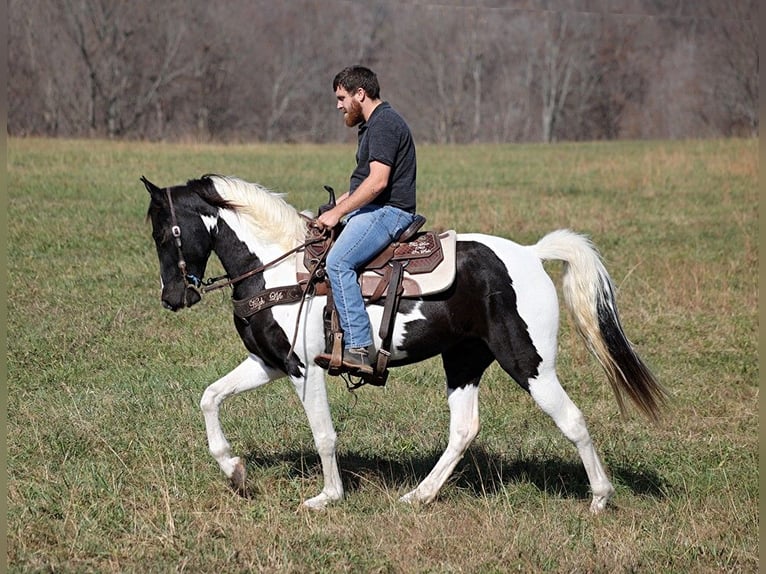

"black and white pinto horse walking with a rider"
[141, 174, 666, 513]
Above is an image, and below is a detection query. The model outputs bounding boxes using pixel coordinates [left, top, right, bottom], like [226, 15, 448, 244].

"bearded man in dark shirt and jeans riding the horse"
[316, 66, 417, 374]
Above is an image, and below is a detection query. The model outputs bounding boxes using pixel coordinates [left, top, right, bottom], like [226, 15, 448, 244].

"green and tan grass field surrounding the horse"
[7, 139, 759, 573]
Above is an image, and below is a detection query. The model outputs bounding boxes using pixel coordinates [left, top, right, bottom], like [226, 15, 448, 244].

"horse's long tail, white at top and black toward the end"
[532, 229, 666, 421]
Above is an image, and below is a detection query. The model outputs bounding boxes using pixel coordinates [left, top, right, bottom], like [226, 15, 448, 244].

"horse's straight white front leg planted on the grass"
[293, 365, 343, 509]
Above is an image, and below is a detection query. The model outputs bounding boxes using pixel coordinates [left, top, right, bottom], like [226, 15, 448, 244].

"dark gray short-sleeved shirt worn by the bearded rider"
[350, 102, 417, 213]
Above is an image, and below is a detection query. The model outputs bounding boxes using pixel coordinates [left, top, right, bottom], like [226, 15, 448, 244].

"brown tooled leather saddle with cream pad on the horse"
[296, 215, 457, 388]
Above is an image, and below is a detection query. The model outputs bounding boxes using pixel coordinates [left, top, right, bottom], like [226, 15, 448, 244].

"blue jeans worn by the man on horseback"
[326, 205, 415, 349]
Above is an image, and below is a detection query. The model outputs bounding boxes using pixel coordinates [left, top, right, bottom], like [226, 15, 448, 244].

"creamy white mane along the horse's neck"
[210, 175, 306, 251]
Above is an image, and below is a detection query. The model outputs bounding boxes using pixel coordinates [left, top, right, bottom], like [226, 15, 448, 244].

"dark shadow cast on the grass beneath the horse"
[238, 446, 668, 500]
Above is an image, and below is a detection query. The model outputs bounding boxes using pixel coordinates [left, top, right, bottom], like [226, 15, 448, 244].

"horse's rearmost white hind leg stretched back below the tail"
[529, 369, 614, 513]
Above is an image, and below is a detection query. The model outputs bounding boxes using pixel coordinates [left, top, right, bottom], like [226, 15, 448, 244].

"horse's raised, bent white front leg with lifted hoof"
[200, 355, 284, 493]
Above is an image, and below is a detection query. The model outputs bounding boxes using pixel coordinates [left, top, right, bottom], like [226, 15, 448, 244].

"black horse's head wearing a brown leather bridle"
[141, 177, 216, 311]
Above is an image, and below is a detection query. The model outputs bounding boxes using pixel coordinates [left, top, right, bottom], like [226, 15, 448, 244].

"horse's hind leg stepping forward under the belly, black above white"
[400, 343, 492, 504]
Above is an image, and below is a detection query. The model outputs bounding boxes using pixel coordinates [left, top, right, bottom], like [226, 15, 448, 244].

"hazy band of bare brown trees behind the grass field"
[7, 0, 758, 143]
